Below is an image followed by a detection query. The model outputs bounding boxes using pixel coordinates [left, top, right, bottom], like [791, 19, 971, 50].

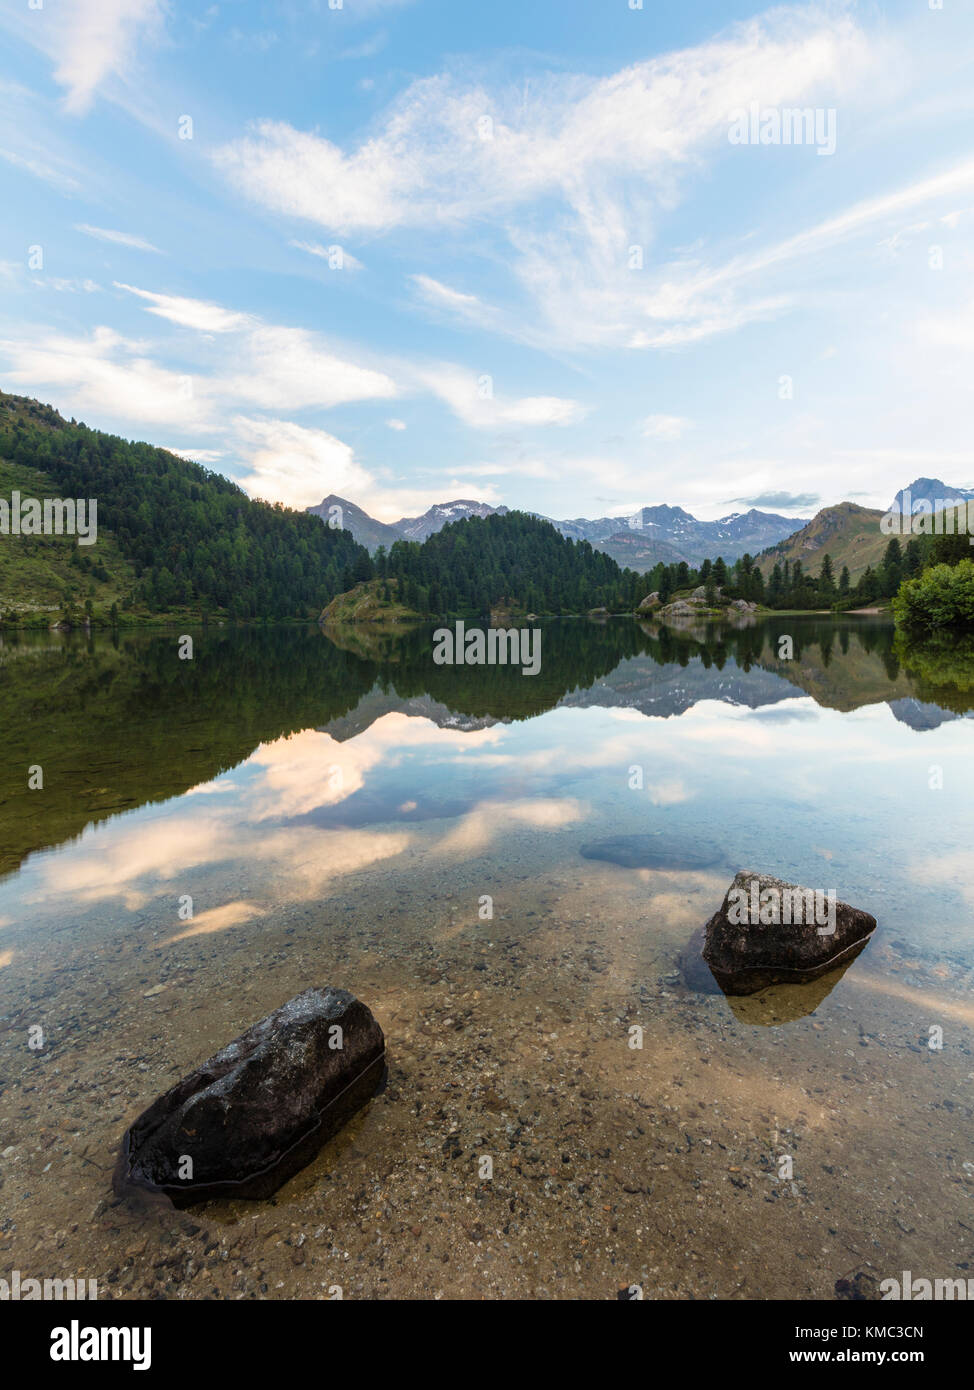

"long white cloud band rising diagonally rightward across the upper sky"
[214, 10, 870, 240]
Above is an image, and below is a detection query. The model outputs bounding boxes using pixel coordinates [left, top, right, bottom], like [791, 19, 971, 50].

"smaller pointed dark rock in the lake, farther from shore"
[703, 870, 875, 994]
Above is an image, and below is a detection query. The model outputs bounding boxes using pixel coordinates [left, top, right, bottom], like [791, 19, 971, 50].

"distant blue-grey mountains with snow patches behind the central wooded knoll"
[308, 493, 806, 574]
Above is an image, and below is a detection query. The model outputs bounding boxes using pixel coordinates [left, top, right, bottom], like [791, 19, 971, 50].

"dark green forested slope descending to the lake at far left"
[0, 392, 371, 619]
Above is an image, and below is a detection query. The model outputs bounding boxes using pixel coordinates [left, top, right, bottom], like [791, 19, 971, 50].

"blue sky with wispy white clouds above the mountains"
[0, 0, 974, 521]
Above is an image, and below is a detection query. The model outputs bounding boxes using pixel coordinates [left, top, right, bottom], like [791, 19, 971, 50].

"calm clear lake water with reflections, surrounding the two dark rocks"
[0, 617, 974, 1298]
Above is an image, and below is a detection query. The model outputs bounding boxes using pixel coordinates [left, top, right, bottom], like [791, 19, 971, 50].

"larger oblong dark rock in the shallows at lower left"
[113, 988, 385, 1207]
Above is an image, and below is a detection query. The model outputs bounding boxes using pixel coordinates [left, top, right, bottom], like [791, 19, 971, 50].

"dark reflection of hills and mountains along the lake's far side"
[0, 617, 974, 873]
